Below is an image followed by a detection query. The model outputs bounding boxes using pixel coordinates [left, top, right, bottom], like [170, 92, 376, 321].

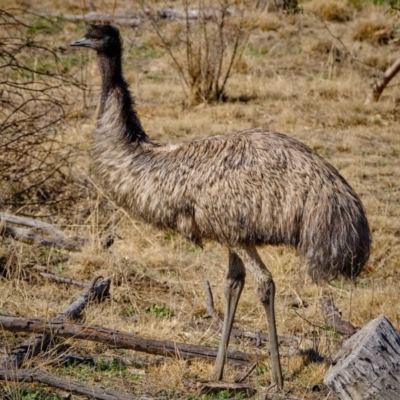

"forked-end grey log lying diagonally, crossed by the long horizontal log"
[0, 277, 111, 369]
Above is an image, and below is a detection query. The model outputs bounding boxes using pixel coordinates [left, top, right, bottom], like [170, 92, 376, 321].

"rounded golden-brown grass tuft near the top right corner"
[352, 14, 395, 45]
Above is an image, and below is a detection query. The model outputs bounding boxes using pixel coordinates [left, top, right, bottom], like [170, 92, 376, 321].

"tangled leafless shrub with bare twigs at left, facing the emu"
[0, 10, 83, 214]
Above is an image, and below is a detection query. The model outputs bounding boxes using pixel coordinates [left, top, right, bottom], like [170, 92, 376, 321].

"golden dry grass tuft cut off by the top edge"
[304, 0, 353, 22]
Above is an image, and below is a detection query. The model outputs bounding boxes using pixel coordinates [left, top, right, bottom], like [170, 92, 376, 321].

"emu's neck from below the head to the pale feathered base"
[98, 54, 149, 143]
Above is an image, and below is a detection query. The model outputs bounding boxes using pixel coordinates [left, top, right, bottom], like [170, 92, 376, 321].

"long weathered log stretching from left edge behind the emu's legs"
[0, 316, 258, 364]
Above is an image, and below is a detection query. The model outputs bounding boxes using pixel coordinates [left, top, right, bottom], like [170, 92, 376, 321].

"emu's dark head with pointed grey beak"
[71, 25, 122, 57]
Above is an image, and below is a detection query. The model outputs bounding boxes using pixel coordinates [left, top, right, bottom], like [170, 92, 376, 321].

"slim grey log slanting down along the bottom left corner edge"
[0, 369, 135, 400]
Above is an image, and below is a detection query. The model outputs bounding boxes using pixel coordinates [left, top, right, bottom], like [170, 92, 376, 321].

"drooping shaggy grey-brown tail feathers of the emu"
[299, 191, 371, 281]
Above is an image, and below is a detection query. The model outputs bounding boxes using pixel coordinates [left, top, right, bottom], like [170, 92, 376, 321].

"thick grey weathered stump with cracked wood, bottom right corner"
[324, 315, 400, 400]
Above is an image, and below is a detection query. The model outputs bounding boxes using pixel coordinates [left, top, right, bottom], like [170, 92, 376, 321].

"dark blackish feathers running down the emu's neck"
[98, 50, 149, 143]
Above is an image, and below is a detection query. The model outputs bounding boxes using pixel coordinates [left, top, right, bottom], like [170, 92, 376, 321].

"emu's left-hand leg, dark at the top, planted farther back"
[210, 250, 246, 381]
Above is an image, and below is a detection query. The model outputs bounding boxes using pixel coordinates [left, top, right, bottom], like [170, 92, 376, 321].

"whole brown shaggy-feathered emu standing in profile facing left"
[71, 25, 371, 388]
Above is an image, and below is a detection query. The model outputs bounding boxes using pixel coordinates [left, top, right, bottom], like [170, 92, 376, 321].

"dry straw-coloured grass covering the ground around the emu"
[0, 0, 400, 400]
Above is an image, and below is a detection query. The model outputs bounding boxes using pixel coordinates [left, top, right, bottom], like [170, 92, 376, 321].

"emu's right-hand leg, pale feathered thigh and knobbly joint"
[235, 247, 283, 389]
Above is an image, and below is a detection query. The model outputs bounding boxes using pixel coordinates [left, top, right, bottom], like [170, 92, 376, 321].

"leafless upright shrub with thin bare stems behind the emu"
[151, 0, 247, 104]
